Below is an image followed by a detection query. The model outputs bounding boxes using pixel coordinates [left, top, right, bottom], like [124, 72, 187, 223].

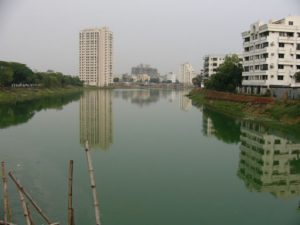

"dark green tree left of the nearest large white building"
[204, 55, 243, 92]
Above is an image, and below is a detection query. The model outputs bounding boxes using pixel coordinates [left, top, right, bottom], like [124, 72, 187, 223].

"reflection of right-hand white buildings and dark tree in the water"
[202, 106, 300, 198]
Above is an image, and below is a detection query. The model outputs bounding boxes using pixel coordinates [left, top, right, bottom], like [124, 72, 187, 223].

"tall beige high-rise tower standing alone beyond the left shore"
[79, 27, 113, 87]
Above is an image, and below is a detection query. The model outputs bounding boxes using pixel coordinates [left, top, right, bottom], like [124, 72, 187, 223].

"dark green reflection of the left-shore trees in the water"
[0, 92, 82, 129]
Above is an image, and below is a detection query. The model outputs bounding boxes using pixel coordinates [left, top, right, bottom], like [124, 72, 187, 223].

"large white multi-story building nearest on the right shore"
[242, 16, 300, 94]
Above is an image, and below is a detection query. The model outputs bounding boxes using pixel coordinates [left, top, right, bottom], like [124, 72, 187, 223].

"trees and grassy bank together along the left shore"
[0, 61, 83, 104]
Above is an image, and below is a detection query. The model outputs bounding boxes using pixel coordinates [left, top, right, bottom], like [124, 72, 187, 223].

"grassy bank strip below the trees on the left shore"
[0, 87, 83, 104]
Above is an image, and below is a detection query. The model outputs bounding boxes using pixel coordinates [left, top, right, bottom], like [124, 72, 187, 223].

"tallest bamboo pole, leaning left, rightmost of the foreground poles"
[85, 141, 101, 225]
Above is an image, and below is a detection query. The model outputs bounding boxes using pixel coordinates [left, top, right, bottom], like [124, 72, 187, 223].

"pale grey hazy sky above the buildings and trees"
[0, 0, 300, 75]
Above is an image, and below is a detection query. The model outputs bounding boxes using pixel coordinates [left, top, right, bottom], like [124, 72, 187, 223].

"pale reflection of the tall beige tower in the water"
[80, 90, 113, 150]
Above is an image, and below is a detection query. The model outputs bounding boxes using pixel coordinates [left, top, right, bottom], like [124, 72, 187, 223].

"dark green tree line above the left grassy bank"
[0, 61, 83, 88]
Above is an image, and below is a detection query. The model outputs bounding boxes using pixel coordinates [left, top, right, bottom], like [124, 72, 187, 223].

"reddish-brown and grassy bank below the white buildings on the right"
[188, 89, 300, 125]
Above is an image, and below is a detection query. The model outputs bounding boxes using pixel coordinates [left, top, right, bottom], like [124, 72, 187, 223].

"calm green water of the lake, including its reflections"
[0, 89, 300, 225]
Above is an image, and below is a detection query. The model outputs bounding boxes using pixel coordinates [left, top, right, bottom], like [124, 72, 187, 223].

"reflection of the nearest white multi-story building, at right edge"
[238, 121, 300, 198]
